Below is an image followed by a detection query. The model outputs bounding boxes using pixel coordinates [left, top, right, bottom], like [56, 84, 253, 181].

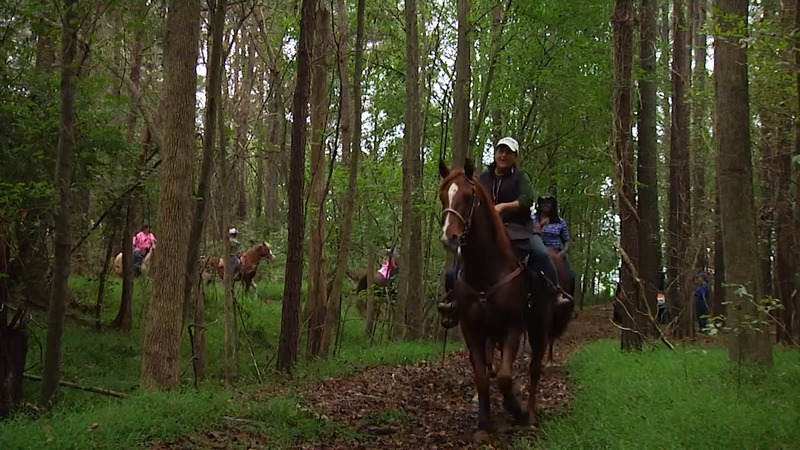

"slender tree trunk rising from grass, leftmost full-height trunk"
[39, 0, 79, 408]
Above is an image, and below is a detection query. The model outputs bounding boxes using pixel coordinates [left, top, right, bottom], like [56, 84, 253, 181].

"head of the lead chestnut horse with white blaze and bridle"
[439, 158, 480, 252]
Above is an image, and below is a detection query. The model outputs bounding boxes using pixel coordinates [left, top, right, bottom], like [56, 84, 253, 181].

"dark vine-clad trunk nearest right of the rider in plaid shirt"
[611, 0, 642, 350]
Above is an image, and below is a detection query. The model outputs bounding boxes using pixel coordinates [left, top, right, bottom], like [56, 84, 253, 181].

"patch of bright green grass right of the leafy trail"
[517, 341, 800, 449]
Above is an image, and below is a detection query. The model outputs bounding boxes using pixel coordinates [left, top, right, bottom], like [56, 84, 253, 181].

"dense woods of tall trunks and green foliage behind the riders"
[0, 0, 800, 442]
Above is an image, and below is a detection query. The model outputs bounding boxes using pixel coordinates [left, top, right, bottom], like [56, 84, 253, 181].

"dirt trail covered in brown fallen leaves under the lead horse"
[151, 307, 616, 450]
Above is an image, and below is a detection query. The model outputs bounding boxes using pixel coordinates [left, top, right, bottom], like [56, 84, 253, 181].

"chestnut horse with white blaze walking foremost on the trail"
[439, 160, 556, 433]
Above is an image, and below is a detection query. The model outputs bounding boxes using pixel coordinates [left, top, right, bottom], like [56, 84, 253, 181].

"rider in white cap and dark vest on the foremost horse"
[439, 137, 558, 328]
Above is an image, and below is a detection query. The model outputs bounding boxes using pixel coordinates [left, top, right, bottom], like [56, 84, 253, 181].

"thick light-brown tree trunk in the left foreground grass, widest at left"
[140, 0, 200, 390]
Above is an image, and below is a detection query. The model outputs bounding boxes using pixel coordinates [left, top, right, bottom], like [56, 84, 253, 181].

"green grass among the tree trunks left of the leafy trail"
[0, 277, 444, 450]
